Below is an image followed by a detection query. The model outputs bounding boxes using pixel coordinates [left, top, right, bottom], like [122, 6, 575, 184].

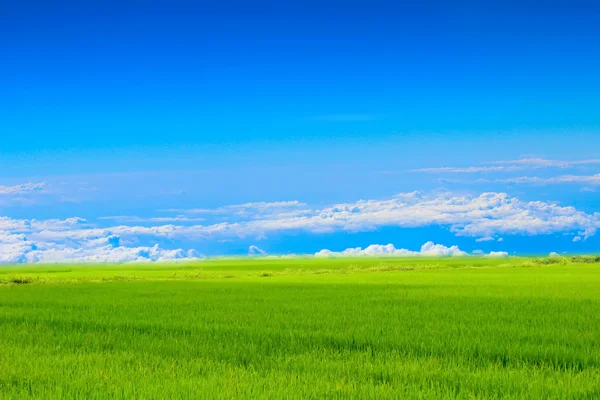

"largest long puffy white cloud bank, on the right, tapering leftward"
[220, 193, 600, 238]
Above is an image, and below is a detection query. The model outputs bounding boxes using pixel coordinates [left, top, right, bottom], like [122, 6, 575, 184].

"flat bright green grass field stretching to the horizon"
[0, 257, 600, 399]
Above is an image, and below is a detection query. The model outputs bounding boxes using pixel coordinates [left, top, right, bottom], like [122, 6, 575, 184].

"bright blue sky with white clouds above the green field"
[0, 0, 600, 263]
